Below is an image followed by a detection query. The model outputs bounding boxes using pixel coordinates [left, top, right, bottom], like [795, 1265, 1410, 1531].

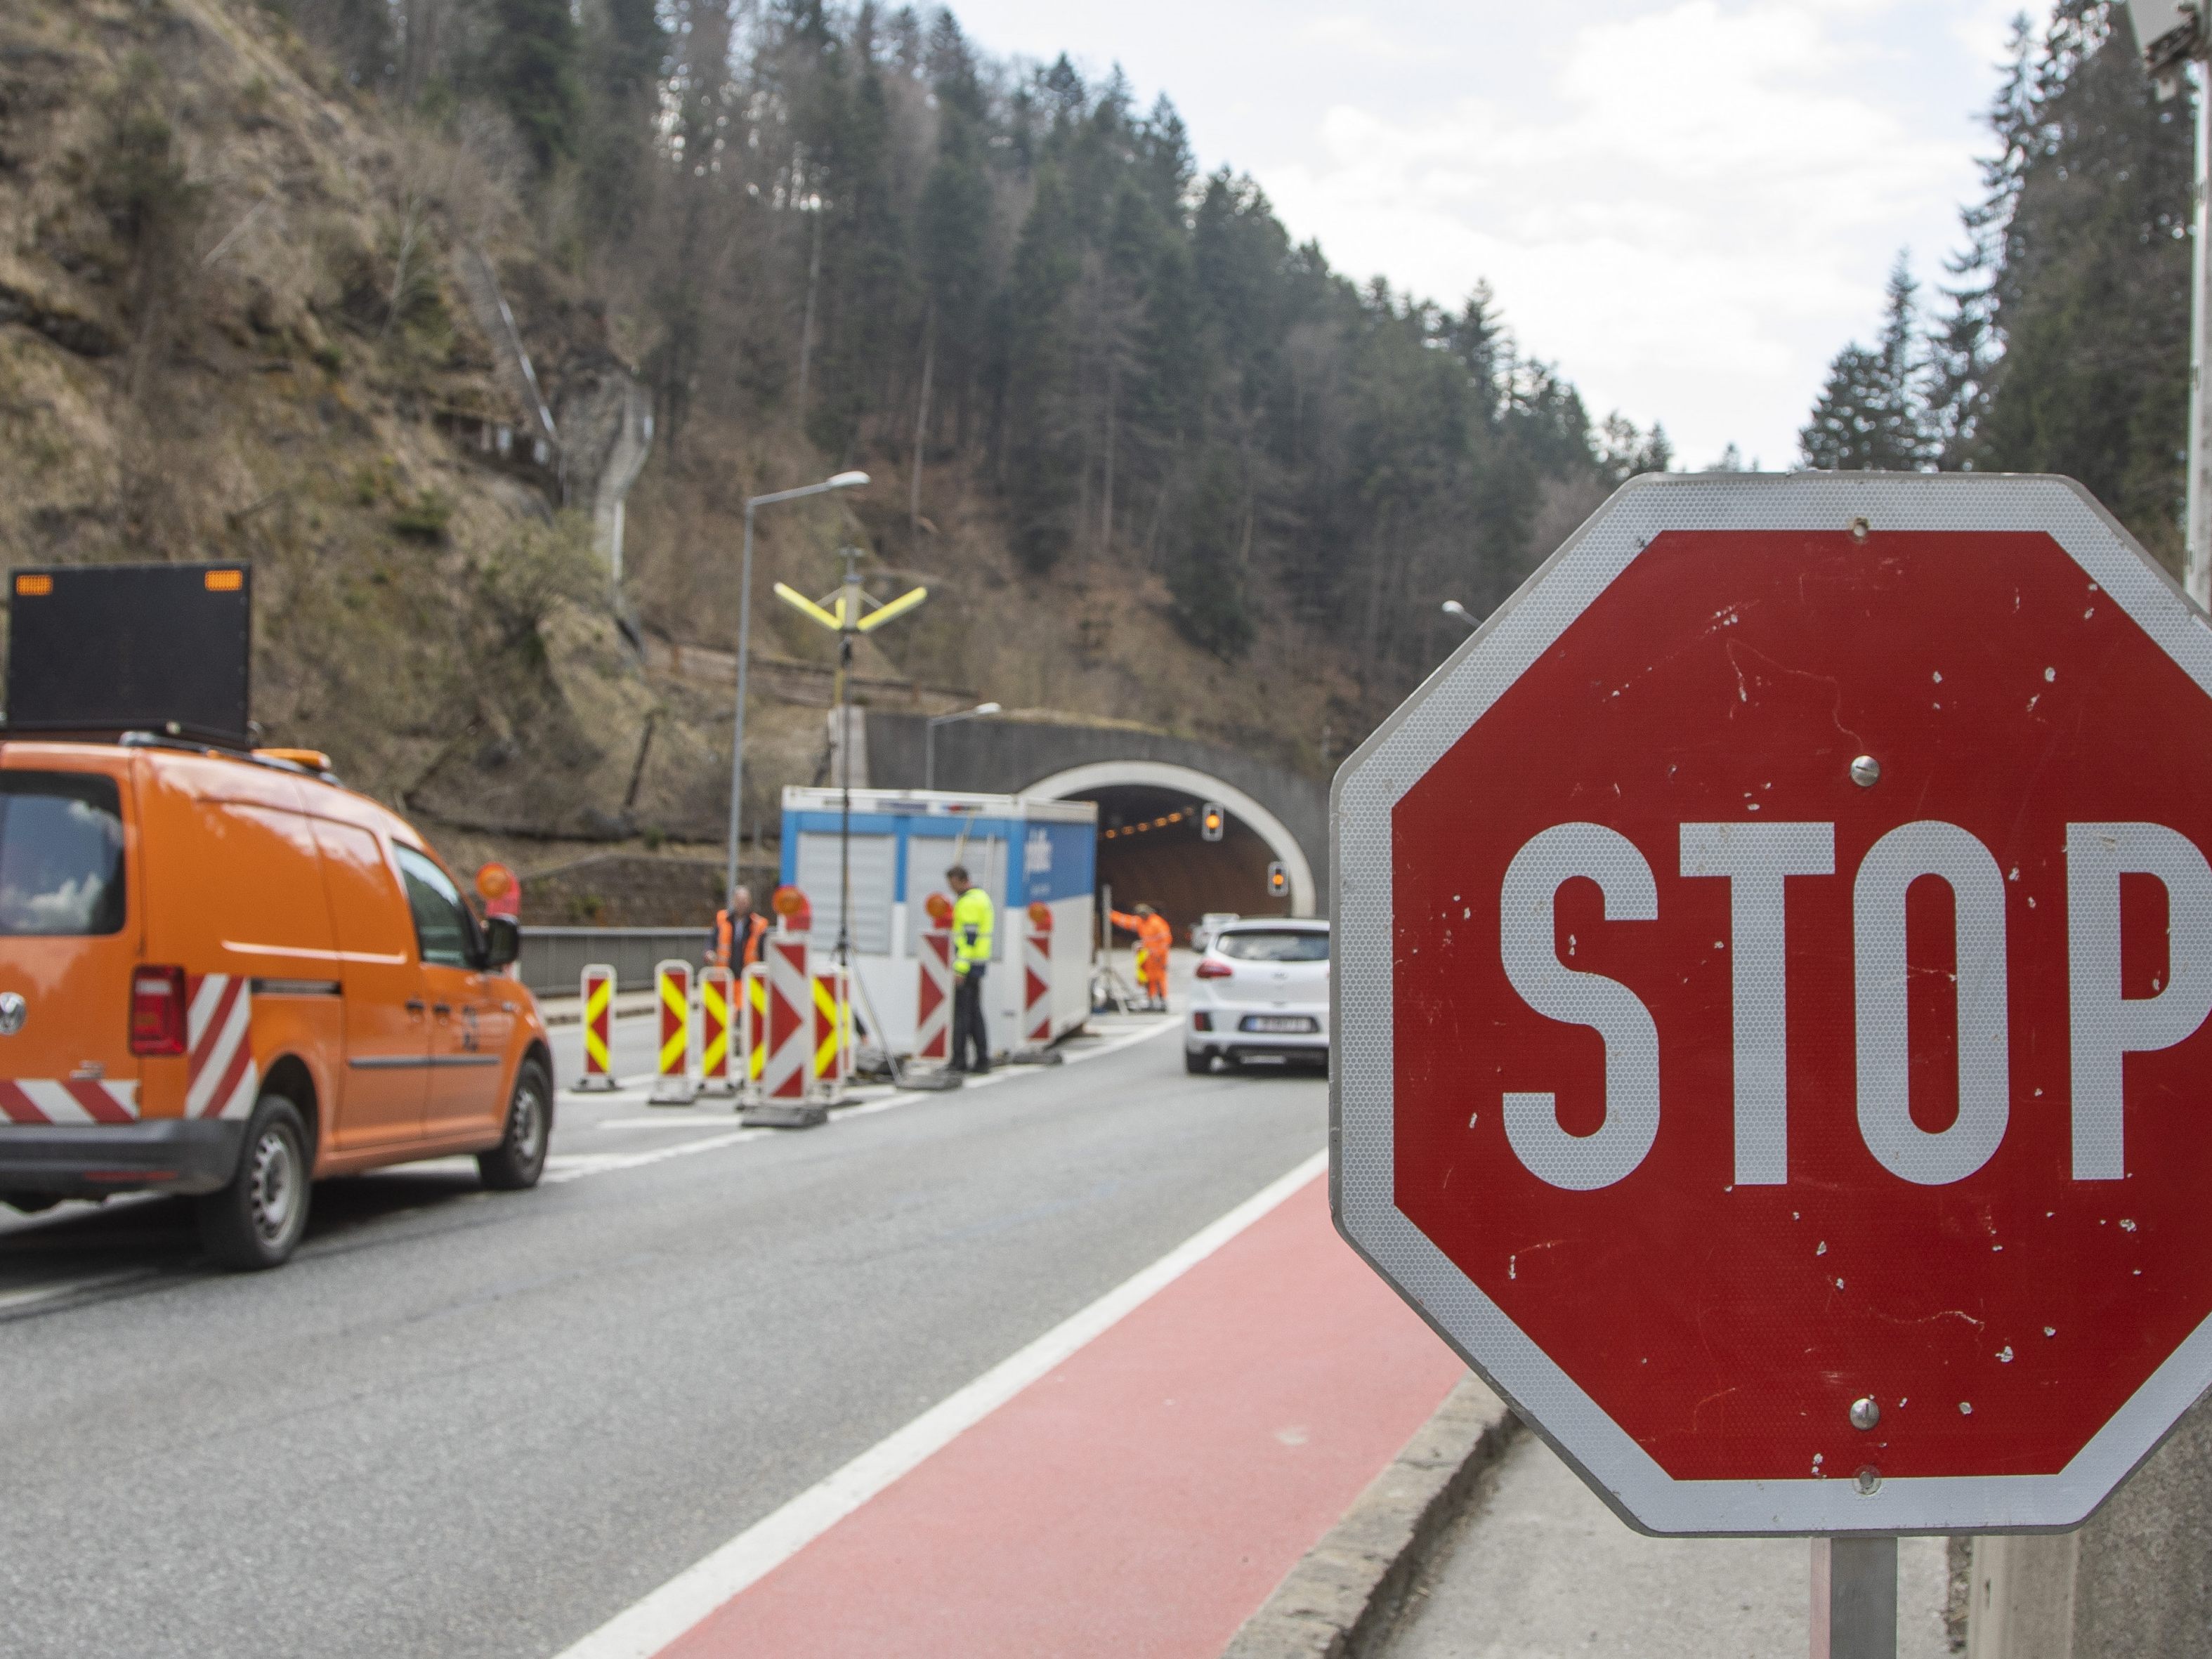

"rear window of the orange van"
[0, 772, 124, 936]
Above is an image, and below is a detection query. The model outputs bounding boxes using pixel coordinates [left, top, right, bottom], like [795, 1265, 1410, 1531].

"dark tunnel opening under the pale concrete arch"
[1062, 783, 1290, 943]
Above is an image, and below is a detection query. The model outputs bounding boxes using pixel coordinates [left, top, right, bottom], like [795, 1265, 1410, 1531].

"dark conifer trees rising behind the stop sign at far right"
[1802, 0, 2194, 568]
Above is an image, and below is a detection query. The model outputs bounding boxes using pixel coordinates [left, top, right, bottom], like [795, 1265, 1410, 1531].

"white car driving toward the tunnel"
[1184, 916, 1330, 1073]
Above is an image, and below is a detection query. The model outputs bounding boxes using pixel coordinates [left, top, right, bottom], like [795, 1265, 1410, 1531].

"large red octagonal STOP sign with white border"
[1334, 476, 2212, 1533]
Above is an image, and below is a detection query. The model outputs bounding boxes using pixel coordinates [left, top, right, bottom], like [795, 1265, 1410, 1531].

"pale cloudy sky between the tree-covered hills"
[953, 0, 2022, 469]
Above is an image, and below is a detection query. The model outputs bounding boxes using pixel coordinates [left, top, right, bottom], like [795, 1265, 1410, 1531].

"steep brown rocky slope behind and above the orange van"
[0, 0, 728, 839]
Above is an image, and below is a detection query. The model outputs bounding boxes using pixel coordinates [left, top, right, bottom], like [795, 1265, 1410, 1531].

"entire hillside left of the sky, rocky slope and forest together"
[0, 0, 1665, 865]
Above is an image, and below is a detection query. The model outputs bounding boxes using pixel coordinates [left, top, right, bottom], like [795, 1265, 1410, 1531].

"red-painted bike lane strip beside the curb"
[664, 1176, 1465, 1659]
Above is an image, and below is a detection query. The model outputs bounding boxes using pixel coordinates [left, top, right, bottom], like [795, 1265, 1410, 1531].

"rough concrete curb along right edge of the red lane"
[1223, 1376, 1519, 1659]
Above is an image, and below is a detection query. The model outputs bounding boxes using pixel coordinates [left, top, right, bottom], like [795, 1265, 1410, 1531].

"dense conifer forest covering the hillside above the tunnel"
[272, 0, 1663, 766]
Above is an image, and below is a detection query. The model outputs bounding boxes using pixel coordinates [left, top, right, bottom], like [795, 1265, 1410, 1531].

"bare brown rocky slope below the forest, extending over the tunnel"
[0, 0, 1504, 898]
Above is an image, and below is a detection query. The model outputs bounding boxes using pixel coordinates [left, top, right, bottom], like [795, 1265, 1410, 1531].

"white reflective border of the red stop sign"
[1330, 473, 2212, 1533]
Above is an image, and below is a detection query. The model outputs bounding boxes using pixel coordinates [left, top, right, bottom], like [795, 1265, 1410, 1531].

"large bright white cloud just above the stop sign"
[1259, 0, 1999, 464]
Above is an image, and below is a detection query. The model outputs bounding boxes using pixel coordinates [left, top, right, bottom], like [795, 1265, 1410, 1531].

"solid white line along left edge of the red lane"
[560, 1150, 1330, 1659]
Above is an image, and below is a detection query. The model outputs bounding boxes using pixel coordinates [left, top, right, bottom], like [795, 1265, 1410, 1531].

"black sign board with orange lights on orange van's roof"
[6, 564, 254, 747]
